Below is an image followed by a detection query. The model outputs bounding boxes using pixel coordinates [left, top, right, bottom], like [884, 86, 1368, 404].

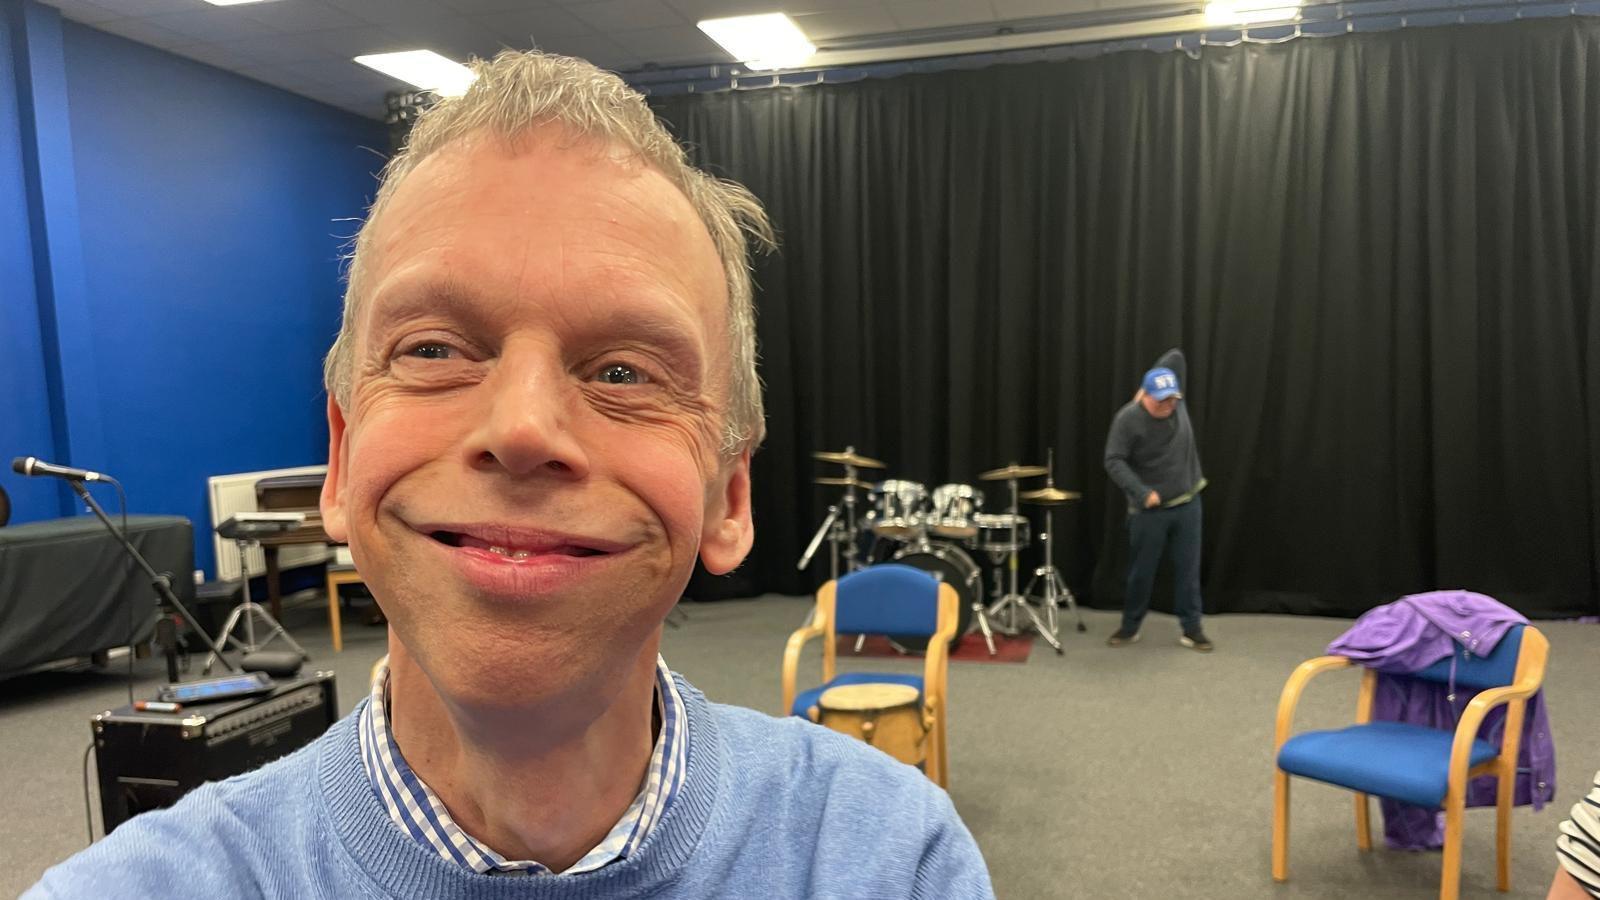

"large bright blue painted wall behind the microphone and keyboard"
[0, 0, 387, 575]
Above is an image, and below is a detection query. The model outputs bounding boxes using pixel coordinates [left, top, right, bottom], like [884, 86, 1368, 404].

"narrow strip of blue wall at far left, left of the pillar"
[0, 16, 59, 522]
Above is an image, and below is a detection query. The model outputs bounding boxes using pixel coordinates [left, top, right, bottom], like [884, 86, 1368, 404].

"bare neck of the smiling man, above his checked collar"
[389, 639, 658, 871]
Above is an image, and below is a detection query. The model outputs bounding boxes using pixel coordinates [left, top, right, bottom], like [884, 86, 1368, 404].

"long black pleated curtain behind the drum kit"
[653, 18, 1600, 617]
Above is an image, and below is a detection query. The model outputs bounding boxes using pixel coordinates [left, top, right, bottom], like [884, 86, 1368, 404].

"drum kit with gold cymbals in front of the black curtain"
[798, 447, 1086, 657]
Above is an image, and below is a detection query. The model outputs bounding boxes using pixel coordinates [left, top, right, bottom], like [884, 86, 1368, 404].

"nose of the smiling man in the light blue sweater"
[472, 346, 589, 477]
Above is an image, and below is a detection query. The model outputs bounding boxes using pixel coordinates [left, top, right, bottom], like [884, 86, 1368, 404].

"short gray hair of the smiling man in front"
[323, 50, 776, 455]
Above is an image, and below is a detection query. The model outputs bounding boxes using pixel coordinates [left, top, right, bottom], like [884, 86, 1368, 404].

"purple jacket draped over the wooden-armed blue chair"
[1328, 591, 1555, 850]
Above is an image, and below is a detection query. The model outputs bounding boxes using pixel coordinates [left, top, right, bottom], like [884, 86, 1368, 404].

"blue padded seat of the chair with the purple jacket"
[1278, 722, 1499, 807]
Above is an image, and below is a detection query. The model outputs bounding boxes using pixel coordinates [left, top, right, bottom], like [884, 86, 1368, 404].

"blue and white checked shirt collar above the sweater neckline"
[358, 657, 688, 874]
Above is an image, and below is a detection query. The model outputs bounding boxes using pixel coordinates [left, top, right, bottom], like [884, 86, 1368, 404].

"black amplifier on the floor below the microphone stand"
[90, 673, 339, 834]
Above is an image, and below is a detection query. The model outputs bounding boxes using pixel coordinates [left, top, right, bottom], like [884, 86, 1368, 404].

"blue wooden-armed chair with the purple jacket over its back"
[1272, 626, 1550, 900]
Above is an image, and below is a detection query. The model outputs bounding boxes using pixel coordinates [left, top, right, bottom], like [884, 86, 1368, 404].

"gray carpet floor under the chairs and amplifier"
[0, 597, 1600, 900]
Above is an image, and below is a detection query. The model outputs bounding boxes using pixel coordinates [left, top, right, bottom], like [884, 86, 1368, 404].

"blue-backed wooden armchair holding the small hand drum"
[782, 564, 960, 788]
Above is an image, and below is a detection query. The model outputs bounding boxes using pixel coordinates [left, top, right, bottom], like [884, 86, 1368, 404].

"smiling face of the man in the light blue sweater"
[323, 128, 752, 706]
